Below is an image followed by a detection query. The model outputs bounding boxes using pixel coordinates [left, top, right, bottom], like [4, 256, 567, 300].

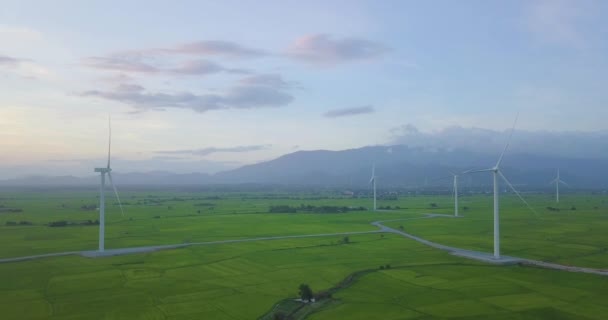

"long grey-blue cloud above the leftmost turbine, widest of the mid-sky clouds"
[80, 84, 293, 112]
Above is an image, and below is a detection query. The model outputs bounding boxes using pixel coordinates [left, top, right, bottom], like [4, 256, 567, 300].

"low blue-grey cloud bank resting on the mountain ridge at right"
[389, 124, 608, 158]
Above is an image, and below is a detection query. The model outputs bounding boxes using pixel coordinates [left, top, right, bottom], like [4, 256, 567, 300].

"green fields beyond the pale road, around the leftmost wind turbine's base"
[0, 192, 408, 258]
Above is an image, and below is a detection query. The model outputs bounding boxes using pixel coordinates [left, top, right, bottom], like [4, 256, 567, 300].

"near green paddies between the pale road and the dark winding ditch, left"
[0, 235, 459, 319]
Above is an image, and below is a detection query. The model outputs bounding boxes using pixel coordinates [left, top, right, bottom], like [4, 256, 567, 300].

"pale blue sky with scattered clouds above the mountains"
[0, 0, 608, 177]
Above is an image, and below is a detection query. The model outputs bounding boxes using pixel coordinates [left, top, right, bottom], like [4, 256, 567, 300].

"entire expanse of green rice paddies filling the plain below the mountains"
[0, 189, 608, 319]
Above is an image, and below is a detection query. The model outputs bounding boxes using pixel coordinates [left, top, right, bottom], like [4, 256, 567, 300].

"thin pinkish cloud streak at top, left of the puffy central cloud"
[167, 40, 266, 58]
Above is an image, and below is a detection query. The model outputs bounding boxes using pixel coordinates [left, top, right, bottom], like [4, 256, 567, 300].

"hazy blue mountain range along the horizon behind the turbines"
[0, 145, 608, 189]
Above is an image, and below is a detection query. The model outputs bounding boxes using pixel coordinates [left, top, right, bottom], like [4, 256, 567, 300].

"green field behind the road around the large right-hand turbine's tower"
[387, 195, 608, 269]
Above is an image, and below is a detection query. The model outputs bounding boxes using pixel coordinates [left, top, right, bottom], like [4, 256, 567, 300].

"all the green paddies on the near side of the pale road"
[0, 235, 608, 319]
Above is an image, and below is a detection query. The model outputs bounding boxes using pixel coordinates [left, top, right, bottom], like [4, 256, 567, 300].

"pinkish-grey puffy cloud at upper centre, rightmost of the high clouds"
[287, 34, 388, 66]
